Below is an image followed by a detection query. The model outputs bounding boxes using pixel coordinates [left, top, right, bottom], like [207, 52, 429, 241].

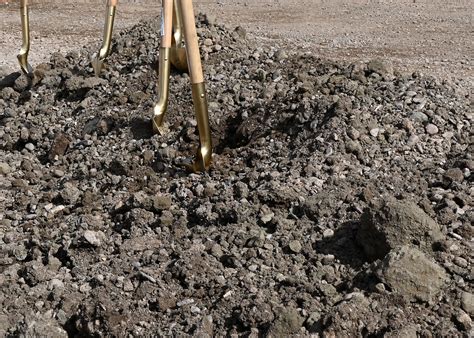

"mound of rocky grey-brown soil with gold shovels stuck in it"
[0, 15, 474, 337]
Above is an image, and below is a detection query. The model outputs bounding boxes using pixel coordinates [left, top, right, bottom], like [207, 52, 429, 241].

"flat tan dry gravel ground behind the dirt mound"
[0, 0, 474, 85]
